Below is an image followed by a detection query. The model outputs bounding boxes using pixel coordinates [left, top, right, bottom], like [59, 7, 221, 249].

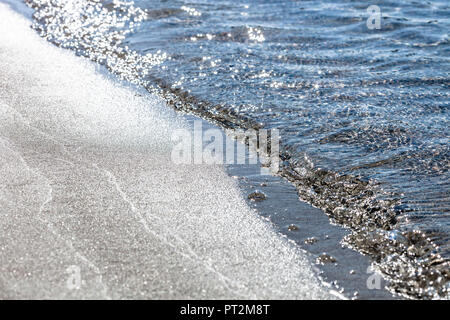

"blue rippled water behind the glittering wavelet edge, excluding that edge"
[124, 1, 450, 250]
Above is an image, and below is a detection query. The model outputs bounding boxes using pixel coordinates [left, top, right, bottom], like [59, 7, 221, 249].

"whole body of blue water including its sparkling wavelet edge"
[21, 0, 450, 297]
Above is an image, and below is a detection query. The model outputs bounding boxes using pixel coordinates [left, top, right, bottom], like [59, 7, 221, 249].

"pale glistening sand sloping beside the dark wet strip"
[0, 4, 332, 299]
